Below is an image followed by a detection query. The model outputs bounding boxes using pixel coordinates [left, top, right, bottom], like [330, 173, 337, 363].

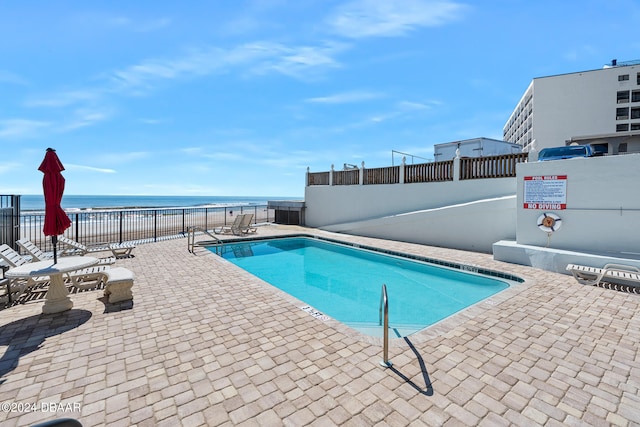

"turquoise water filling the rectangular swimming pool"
[222, 237, 509, 336]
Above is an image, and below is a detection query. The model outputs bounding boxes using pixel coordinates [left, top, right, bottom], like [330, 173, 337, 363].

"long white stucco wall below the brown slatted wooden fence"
[305, 178, 516, 252]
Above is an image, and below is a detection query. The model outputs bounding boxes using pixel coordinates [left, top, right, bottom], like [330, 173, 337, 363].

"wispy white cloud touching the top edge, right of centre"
[329, 0, 466, 38]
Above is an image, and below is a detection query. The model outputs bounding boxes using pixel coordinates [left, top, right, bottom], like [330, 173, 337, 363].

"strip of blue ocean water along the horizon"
[20, 194, 302, 211]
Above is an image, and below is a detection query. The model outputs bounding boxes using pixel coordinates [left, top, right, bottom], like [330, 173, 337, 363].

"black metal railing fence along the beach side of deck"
[0, 205, 275, 251]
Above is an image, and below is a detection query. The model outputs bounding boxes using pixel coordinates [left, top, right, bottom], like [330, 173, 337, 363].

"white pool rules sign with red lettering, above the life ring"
[524, 175, 567, 210]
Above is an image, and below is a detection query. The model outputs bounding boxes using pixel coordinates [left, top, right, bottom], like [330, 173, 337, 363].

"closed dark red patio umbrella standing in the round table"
[38, 148, 71, 263]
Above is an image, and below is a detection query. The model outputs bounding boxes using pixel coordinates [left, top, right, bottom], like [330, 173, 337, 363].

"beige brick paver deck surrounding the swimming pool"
[0, 226, 640, 426]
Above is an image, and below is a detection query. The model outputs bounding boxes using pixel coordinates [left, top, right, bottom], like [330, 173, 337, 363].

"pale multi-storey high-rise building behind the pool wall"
[503, 60, 640, 154]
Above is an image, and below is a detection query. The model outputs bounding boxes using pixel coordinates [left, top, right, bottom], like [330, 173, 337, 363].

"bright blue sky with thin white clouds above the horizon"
[0, 0, 640, 197]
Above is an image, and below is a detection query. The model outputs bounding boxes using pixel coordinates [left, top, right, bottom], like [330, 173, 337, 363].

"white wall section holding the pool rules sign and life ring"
[516, 154, 640, 253]
